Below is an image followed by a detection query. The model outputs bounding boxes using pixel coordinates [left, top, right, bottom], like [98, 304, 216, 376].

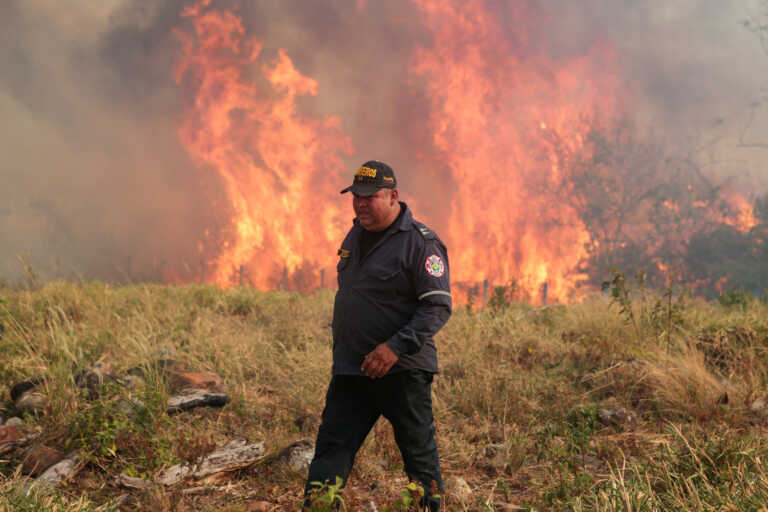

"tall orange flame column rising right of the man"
[413, 0, 617, 299]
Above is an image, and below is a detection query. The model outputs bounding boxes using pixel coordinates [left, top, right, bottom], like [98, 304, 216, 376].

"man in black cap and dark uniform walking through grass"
[306, 161, 451, 510]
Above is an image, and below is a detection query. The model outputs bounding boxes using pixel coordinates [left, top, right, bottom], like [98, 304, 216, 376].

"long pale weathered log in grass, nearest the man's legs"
[157, 439, 264, 486]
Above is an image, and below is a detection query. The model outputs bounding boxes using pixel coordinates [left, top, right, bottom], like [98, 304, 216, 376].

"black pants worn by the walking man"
[306, 370, 443, 510]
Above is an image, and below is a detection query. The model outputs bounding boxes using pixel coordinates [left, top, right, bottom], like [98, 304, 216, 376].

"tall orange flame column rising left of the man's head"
[176, 0, 352, 288]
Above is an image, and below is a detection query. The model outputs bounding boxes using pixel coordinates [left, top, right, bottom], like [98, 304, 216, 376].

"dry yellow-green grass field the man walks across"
[0, 282, 768, 512]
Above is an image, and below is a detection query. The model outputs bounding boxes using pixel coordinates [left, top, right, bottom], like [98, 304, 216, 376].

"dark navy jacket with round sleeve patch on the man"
[333, 202, 451, 375]
